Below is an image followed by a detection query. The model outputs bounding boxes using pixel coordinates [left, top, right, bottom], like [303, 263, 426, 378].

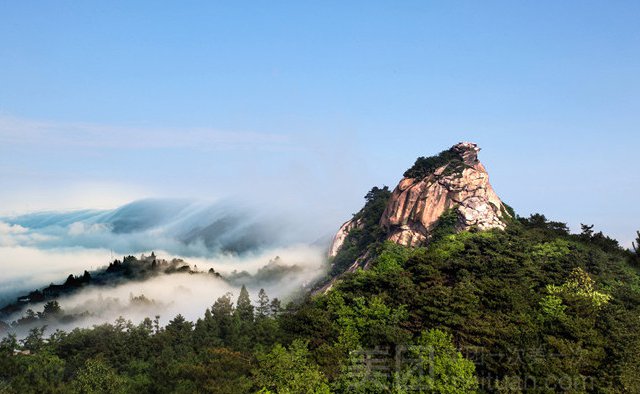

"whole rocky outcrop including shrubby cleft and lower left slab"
[320, 142, 513, 294]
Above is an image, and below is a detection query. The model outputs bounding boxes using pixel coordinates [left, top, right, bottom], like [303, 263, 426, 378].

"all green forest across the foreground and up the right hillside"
[0, 189, 640, 393]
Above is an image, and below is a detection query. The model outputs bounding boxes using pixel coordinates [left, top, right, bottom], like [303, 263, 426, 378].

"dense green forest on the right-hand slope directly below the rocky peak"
[330, 220, 640, 392]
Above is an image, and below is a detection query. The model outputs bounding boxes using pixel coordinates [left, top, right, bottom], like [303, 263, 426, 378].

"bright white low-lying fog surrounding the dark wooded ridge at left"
[0, 245, 324, 331]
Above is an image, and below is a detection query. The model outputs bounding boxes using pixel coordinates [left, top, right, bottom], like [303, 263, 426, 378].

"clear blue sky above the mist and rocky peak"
[0, 1, 640, 245]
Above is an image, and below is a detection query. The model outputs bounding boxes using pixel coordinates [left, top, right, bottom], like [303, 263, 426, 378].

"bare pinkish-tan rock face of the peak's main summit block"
[380, 142, 509, 246]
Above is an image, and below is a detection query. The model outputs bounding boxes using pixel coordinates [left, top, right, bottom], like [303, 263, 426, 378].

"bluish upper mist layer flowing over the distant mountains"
[0, 199, 329, 257]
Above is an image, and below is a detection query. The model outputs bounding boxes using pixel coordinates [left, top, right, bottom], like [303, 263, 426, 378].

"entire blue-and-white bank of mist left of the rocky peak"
[0, 199, 338, 335]
